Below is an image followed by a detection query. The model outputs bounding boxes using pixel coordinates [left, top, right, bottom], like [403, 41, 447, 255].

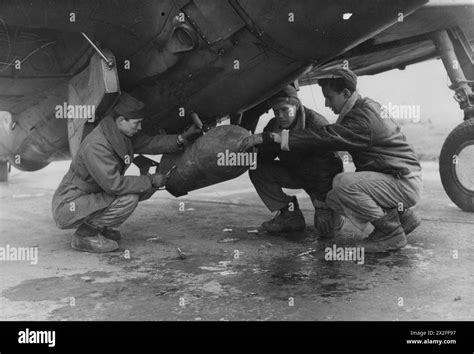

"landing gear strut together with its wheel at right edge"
[433, 29, 474, 212]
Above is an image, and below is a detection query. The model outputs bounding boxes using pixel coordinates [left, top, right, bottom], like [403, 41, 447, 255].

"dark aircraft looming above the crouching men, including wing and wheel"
[0, 0, 474, 211]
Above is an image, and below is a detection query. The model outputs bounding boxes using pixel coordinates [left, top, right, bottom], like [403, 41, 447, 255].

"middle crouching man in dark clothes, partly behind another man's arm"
[241, 86, 343, 236]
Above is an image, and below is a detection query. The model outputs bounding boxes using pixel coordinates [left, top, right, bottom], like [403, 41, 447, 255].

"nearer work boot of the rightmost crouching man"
[361, 209, 407, 253]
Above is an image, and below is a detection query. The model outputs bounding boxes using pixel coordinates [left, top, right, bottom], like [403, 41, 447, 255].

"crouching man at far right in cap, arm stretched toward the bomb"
[264, 68, 423, 252]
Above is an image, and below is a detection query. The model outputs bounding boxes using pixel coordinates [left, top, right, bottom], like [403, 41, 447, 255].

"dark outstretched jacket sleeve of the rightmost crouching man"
[281, 116, 372, 151]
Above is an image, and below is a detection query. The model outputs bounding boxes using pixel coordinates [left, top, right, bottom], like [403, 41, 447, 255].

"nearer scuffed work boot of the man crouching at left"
[71, 223, 118, 253]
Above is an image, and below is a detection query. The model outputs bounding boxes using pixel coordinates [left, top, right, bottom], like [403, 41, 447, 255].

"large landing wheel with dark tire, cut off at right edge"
[439, 119, 474, 212]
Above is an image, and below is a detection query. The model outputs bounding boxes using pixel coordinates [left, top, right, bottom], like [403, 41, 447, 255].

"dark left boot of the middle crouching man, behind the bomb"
[262, 197, 306, 232]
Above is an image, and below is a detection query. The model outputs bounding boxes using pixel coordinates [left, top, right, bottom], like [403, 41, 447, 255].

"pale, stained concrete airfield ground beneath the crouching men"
[0, 162, 474, 321]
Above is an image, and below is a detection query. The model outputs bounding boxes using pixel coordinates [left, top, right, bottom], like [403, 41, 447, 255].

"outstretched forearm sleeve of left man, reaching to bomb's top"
[132, 133, 181, 155]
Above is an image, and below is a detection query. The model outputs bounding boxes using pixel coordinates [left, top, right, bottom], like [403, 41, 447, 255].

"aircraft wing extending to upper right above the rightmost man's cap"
[299, 0, 474, 86]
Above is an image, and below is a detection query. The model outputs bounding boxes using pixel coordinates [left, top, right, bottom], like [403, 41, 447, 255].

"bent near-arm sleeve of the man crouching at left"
[84, 145, 152, 196]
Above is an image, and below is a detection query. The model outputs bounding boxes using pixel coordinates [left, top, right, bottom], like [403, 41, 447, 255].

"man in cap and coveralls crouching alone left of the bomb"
[52, 93, 200, 253]
